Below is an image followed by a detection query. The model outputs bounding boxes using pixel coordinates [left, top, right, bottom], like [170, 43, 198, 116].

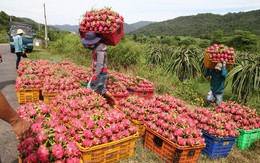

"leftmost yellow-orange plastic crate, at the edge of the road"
[16, 88, 40, 104]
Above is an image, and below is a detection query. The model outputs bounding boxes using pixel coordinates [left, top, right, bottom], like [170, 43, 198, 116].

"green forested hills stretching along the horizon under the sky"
[0, 10, 260, 38]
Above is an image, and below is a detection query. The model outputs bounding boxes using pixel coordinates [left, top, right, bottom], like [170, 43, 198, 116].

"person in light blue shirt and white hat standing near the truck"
[14, 29, 27, 69]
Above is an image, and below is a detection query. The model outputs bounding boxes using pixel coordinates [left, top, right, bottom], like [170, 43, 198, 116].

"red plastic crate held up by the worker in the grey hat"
[80, 24, 124, 46]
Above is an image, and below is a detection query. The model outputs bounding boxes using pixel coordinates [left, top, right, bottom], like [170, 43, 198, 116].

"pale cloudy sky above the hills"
[0, 0, 260, 25]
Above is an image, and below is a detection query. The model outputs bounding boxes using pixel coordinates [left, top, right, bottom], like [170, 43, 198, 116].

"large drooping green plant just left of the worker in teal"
[166, 47, 201, 81]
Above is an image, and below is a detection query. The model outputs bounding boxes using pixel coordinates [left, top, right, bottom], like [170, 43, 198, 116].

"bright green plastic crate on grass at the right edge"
[236, 128, 260, 150]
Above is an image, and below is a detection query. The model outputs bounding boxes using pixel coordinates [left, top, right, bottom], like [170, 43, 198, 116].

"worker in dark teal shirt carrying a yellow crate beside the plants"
[205, 61, 227, 105]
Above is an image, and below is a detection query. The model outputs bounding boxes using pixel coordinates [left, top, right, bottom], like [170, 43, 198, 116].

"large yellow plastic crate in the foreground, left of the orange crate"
[78, 134, 138, 163]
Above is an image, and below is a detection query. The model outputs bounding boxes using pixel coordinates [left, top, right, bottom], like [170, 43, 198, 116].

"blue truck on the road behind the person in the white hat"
[8, 22, 33, 53]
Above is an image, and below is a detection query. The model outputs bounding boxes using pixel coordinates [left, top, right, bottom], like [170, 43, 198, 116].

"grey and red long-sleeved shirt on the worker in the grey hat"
[92, 43, 107, 80]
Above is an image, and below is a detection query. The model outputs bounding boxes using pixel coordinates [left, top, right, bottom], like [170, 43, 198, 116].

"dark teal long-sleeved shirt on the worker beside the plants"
[205, 66, 227, 94]
